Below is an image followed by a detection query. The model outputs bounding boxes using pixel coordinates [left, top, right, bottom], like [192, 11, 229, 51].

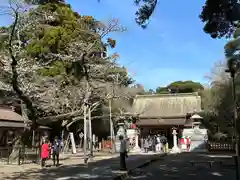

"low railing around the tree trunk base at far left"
[0, 147, 40, 165]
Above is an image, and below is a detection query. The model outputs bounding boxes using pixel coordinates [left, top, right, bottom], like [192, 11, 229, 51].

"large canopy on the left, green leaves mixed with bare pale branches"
[0, 1, 136, 129]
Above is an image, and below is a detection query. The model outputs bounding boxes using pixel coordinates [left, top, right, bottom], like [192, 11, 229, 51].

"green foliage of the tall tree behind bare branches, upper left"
[22, 1, 108, 80]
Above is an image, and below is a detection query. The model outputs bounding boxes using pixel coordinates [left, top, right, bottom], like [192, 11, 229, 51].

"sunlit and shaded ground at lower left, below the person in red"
[0, 154, 163, 180]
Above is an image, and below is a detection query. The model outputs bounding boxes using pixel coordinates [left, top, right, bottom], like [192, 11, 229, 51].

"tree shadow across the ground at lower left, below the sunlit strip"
[1, 155, 152, 180]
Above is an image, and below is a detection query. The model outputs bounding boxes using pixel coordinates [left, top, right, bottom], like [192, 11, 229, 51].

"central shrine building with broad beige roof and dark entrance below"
[132, 93, 201, 145]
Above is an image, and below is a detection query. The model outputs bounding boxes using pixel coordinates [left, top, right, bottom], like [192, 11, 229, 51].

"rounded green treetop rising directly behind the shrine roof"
[156, 81, 204, 93]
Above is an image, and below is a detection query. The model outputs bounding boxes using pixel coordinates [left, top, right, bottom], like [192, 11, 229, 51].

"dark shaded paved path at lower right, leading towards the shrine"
[129, 153, 236, 180]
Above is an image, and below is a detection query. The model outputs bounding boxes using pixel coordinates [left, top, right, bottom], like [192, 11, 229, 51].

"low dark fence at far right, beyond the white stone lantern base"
[208, 141, 235, 152]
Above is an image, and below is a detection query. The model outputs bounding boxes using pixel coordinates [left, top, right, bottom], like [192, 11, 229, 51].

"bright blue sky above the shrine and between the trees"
[0, 0, 226, 89]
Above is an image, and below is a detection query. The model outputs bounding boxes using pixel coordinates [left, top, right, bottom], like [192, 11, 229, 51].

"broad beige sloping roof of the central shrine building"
[132, 93, 201, 118]
